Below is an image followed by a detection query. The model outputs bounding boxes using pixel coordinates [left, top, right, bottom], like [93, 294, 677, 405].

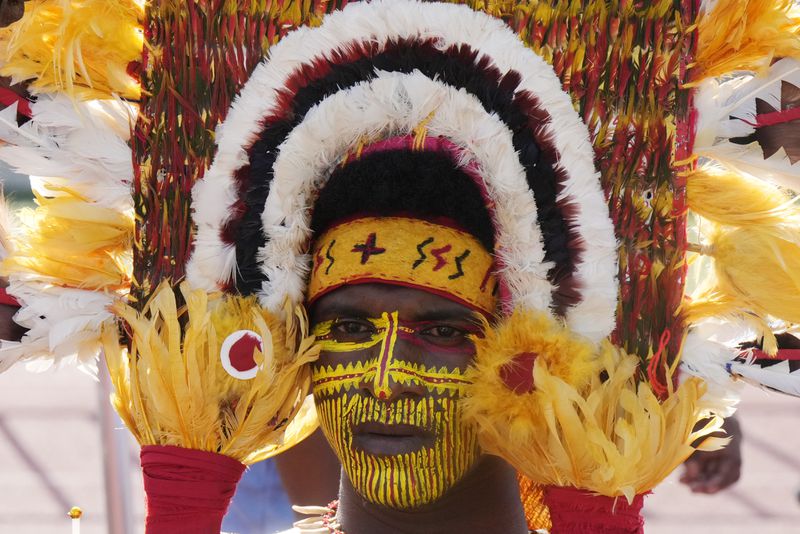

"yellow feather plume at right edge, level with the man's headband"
[682, 165, 800, 354]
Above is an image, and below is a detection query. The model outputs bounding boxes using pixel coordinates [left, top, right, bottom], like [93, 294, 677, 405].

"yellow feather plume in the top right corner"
[692, 0, 800, 82]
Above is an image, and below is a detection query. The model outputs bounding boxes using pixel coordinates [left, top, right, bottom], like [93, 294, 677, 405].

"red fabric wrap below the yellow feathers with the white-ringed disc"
[140, 445, 245, 534]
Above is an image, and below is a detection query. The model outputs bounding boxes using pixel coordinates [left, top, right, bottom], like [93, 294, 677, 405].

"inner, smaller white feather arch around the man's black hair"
[262, 69, 553, 316]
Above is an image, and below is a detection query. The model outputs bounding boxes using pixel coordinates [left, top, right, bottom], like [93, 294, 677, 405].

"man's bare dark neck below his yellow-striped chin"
[338, 456, 528, 534]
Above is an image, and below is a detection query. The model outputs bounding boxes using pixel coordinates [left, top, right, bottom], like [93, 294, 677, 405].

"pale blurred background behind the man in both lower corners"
[0, 167, 800, 534]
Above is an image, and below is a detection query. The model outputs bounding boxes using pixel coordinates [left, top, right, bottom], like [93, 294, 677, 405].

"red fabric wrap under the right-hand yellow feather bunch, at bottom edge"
[544, 486, 644, 534]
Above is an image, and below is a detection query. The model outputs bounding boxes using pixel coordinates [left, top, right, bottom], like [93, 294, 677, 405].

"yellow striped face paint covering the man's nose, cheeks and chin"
[312, 312, 480, 509]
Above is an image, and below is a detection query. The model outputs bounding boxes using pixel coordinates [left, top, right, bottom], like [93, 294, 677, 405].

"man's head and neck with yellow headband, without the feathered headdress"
[284, 149, 528, 533]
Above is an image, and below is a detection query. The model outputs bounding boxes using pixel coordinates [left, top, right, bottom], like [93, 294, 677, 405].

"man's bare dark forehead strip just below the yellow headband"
[310, 283, 474, 322]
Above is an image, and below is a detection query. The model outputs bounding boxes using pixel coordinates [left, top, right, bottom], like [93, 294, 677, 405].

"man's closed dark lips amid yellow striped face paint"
[353, 422, 433, 456]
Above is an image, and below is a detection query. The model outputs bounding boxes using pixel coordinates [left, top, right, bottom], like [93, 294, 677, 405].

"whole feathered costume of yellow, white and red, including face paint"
[0, 0, 800, 534]
